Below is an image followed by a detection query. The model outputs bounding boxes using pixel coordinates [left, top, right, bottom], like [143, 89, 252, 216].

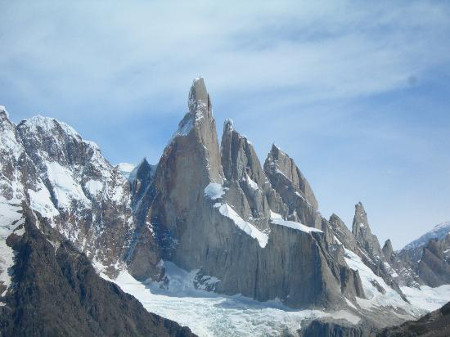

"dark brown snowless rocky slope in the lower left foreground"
[0, 210, 194, 337]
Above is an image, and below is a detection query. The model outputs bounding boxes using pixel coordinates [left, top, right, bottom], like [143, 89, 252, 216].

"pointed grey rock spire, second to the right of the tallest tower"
[264, 144, 322, 229]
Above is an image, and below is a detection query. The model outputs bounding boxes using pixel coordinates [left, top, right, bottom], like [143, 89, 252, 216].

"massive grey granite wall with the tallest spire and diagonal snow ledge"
[139, 79, 360, 307]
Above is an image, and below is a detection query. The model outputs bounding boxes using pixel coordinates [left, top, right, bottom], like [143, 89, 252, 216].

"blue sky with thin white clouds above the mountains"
[0, 0, 450, 248]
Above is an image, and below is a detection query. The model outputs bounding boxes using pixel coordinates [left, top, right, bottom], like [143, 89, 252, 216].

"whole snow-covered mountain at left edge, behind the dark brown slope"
[0, 109, 138, 292]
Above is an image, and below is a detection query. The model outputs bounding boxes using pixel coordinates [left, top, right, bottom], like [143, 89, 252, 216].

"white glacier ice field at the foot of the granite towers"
[102, 262, 450, 337]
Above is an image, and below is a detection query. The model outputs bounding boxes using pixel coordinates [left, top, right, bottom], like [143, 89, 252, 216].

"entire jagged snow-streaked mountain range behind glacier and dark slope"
[0, 78, 450, 334]
